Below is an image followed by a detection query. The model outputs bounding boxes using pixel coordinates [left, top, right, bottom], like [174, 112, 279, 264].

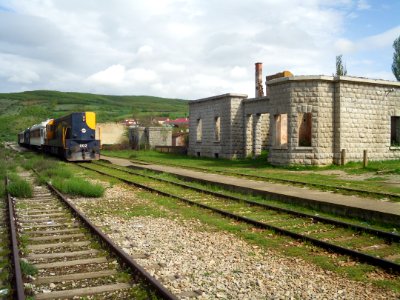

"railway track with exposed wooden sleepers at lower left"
[5, 174, 177, 300]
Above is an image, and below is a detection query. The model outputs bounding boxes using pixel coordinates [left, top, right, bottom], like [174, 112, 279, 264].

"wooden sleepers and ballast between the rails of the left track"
[14, 173, 144, 299]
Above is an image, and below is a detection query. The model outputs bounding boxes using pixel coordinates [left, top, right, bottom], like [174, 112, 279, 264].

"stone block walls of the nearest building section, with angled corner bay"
[269, 76, 400, 165]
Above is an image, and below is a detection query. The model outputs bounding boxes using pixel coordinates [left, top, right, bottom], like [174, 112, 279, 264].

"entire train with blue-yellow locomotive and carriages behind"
[18, 112, 100, 161]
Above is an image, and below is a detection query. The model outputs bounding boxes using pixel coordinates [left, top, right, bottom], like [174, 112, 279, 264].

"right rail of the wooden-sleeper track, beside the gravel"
[38, 177, 178, 300]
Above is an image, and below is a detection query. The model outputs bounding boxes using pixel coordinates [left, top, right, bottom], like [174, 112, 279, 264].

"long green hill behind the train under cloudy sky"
[0, 91, 188, 141]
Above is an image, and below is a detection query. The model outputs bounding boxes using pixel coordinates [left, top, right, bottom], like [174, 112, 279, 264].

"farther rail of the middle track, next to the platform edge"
[95, 163, 400, 242]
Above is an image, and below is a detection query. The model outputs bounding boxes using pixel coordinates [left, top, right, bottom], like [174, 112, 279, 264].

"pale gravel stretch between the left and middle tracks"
[73, 180, 400, 299]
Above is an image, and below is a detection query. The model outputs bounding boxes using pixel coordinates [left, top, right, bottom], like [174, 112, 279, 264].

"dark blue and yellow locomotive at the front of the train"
[43, 112, 100, 161]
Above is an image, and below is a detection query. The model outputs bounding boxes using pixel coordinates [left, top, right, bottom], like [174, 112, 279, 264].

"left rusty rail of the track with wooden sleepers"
[5, 177, 25, 300]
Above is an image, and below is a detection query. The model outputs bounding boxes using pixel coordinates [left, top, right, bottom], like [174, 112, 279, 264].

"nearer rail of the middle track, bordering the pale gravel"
[79, 165, 400, 273]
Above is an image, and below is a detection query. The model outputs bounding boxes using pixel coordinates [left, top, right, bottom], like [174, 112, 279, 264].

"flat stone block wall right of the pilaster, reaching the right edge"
[336, 77, 400, 161]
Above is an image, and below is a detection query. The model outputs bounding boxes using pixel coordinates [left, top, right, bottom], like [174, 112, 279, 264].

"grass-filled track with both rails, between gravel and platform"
[80, 163, 400, 273]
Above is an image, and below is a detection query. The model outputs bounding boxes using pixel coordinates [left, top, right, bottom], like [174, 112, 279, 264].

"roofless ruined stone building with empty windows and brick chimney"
[188, 64, 400, 165]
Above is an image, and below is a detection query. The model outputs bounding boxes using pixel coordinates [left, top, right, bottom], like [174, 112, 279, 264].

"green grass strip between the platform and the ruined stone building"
[102, 150, 400, 201]
